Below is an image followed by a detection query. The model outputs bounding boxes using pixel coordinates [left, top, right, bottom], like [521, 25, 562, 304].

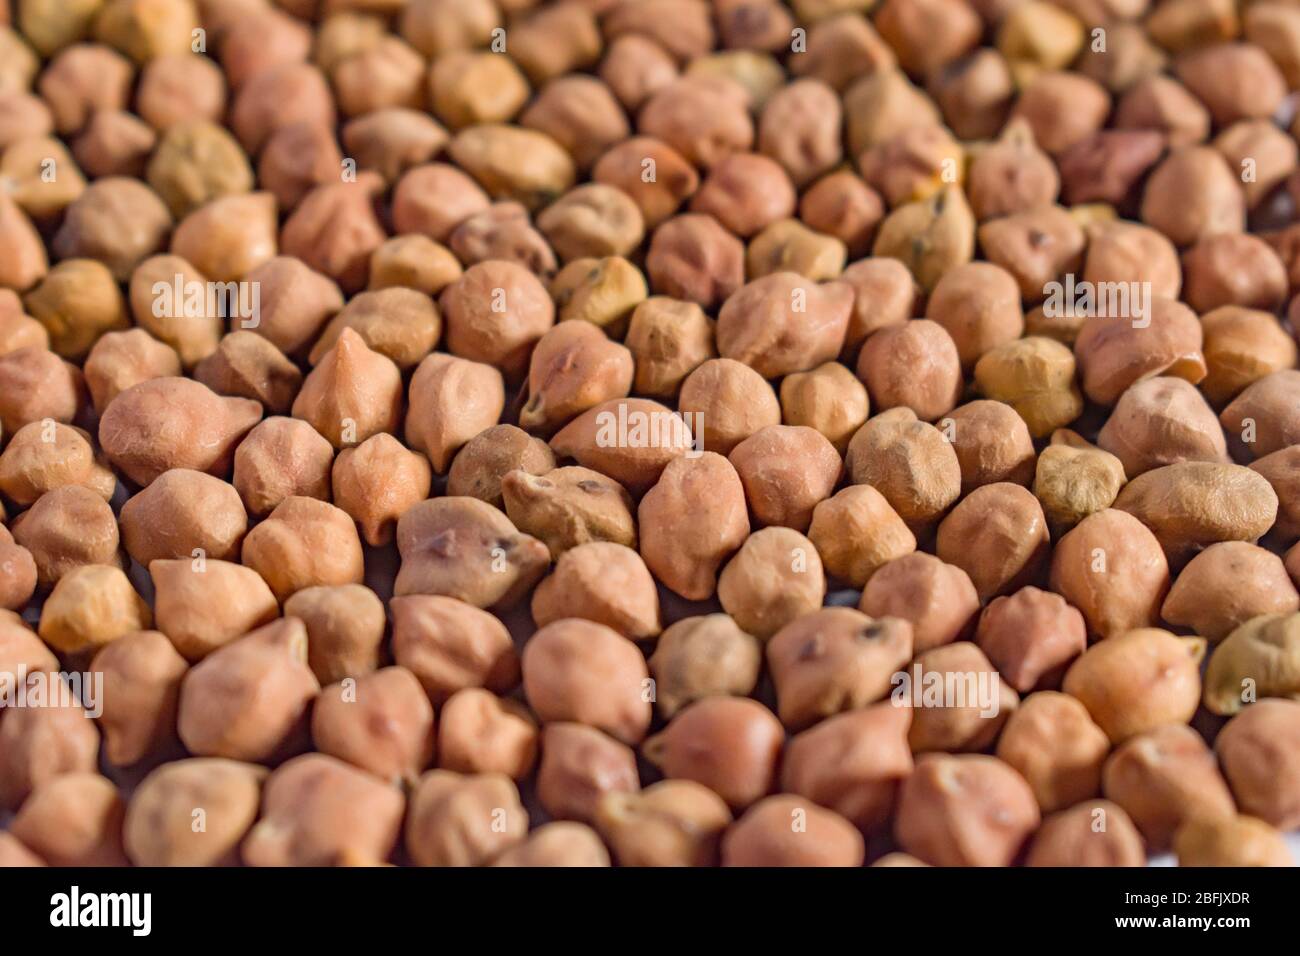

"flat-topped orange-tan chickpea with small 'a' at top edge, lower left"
[150, 561, 280, 663]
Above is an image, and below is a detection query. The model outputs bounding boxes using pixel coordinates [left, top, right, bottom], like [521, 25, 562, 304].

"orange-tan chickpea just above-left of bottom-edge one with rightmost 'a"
[997, 691, 1110, 813]
